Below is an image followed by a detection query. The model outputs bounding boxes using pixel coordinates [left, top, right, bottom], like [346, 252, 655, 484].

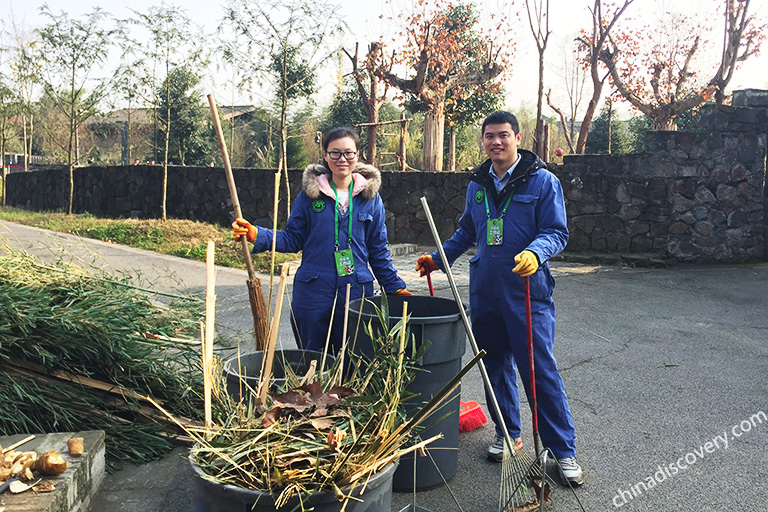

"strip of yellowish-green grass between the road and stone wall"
[0, 208, 301, 273]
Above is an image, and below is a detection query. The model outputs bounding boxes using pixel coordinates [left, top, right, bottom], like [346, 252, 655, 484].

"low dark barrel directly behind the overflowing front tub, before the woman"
[224, 349, 336, 401]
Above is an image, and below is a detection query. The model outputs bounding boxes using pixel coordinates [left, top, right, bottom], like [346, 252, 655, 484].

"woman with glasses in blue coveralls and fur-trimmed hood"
[232, 128, 410, 353]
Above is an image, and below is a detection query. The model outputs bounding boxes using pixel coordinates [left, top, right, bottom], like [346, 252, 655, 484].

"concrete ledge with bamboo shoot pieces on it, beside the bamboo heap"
[0, 430, 105, 512]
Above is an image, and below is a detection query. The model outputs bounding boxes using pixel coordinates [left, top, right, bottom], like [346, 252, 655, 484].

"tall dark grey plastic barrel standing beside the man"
[349, 295, 467, 491]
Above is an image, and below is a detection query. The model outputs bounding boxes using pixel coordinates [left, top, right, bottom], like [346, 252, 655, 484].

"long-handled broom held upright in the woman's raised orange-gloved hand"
[208, 94, 268, 350]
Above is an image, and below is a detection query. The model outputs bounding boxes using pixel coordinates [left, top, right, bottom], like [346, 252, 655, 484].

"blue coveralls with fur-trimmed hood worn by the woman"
[253, 164, 405, 353]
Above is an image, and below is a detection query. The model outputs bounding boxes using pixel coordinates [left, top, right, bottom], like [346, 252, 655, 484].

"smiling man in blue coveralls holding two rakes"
[416, 112, 584, 485]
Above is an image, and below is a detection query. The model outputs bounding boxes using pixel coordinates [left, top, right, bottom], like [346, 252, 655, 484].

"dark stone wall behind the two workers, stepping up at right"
[7, 90, 768, 261]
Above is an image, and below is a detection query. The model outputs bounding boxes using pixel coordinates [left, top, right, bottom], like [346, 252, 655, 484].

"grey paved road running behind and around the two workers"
[0, 223, 768, 512]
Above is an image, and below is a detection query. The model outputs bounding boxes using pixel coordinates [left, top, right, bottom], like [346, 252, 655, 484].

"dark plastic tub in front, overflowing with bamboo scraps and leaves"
[190, 458, 396, 512]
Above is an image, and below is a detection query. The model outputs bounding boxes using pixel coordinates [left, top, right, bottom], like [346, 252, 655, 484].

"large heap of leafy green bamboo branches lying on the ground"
[0, 249, 203, 463]
